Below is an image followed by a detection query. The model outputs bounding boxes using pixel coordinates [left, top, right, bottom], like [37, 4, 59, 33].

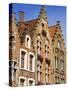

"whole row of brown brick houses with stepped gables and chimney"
[9, 6, 66, 86]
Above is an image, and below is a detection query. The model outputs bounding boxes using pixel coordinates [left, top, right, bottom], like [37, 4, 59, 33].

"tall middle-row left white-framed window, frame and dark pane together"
[20, 49, 27, 69]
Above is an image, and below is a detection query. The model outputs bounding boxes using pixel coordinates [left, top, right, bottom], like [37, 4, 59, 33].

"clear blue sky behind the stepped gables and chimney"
[9, 3, 66, 44]
